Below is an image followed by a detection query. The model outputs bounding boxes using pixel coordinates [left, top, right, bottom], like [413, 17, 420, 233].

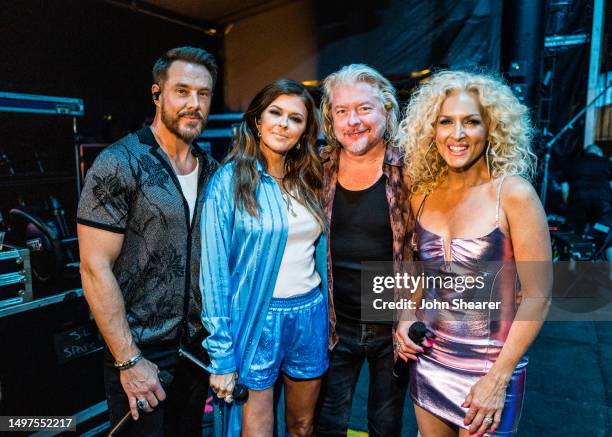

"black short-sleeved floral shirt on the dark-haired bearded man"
[77, 127, 217, 346]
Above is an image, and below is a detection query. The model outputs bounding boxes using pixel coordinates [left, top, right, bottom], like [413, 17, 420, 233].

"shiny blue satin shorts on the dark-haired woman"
[240, 287, 329, 390]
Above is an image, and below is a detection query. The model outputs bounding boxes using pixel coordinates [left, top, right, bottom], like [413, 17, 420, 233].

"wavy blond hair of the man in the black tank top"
[321, 64, 400, 154]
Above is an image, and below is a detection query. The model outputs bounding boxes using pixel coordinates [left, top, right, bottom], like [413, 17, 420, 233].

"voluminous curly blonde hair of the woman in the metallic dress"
[398, 71, 537, 192]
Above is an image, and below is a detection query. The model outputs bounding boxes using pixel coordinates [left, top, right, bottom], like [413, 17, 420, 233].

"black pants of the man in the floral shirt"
[104, 348, 208, 437]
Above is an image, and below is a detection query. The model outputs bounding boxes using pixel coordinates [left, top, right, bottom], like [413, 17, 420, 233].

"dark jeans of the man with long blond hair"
[316, 320, 407, 437]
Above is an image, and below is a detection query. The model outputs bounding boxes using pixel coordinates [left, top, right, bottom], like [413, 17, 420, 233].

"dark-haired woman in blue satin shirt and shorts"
[200, 80, 328, 437]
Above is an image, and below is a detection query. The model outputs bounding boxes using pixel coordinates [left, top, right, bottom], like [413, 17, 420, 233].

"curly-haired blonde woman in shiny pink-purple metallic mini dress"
[397, 71, 552, 437]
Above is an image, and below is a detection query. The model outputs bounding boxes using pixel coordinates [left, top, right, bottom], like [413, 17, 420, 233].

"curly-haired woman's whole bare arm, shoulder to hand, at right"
[461, 176, 552, 435]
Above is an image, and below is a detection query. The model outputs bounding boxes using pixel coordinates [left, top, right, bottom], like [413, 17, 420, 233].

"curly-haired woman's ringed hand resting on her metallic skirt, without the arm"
[461, 372, 510, 436]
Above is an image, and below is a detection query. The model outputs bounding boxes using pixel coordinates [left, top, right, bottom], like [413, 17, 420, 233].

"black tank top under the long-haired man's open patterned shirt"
[330, 176, 393, 322]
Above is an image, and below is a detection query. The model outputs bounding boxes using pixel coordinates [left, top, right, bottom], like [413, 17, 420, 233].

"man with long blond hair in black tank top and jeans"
[317, 64, 413, 436]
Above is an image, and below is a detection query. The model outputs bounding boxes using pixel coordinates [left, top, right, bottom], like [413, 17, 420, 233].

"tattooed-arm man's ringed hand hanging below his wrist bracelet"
[119, 358, 166, 420]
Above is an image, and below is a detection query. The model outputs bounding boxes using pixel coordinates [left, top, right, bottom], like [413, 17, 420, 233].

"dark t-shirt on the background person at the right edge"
[561, 153, 612, 202]
